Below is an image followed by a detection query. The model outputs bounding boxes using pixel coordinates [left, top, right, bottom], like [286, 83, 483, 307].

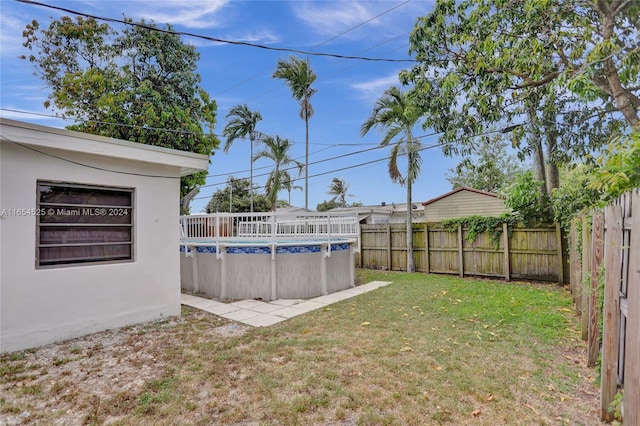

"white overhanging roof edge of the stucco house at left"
[0, 117, 209, 176]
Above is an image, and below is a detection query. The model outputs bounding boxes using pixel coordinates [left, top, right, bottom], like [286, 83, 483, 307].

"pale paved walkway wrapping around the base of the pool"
[180, 281, 391, 327]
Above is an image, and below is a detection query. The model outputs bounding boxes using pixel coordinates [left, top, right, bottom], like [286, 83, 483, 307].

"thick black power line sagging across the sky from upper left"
[16, 0, 418, 63]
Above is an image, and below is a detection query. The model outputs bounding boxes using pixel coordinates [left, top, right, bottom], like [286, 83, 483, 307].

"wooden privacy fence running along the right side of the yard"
[570, 189, 640, 425]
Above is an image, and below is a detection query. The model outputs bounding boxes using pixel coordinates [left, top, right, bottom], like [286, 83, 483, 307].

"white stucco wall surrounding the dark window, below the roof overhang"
[0, 140, 180, 352]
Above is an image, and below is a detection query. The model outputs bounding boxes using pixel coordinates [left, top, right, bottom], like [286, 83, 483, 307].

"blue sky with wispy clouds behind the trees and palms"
[0, 0, 459, 212]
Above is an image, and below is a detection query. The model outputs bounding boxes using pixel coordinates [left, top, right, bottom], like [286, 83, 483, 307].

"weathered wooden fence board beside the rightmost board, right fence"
[600, 205, 622, 422]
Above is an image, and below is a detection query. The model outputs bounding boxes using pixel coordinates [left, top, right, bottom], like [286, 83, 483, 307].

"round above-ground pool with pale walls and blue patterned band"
[180, 213, 359, 301]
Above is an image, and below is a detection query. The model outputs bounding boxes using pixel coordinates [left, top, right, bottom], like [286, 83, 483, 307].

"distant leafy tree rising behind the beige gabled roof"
[445, 136, 521, 192]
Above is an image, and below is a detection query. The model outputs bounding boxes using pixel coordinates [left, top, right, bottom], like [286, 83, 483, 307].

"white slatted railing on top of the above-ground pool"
[180, 213, 360, 243]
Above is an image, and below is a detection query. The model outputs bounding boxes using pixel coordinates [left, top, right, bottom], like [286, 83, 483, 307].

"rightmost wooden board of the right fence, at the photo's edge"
[624, 189, 640, 425]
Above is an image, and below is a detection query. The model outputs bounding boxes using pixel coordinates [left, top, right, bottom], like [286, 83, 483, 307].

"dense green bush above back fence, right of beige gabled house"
[500, 170, 553, 225]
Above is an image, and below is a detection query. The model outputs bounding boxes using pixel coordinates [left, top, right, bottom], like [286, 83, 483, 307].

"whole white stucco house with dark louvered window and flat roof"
[0, 118, 209, 352]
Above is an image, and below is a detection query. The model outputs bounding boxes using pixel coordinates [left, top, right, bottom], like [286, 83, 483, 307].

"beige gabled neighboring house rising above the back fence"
[422, 187, 508, 222]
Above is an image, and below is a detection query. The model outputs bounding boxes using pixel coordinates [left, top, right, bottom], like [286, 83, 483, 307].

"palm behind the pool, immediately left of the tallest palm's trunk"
[253, 136, 303, 212]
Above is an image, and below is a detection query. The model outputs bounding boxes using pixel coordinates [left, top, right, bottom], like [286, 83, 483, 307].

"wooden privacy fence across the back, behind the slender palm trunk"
[356, 223, 569, 283]
